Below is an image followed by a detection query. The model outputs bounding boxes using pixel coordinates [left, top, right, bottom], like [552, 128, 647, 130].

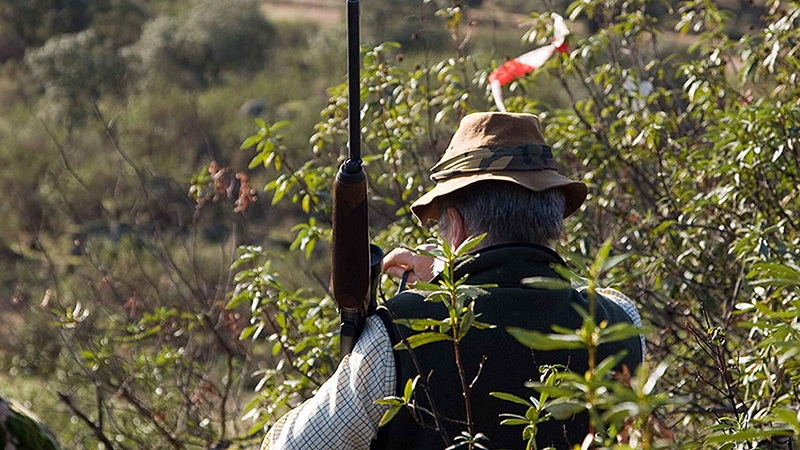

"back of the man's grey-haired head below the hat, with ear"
[439, 181, 566, 247]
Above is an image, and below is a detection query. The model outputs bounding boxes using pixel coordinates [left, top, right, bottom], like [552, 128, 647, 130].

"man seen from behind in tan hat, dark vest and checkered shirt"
[262, 113, 644, 450]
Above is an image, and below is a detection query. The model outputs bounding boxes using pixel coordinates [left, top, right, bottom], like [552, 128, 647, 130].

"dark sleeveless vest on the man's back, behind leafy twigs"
[372, 245, 642, 450]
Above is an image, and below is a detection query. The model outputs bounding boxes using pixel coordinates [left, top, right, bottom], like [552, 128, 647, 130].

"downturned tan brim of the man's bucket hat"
[411, 170, 587, 225]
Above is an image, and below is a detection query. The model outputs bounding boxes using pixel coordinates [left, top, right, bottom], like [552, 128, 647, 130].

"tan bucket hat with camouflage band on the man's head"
[411, 112, 586, 224]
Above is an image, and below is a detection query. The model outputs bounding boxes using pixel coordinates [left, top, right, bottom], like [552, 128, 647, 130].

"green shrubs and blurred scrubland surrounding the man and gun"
[0, 0, 800, 449]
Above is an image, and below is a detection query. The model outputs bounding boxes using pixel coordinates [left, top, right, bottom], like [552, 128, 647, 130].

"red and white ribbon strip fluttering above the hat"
[489, 13, 569, 112]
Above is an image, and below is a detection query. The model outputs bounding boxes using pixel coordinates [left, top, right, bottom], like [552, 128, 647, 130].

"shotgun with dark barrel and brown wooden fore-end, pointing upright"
[331, 0, 383, 358]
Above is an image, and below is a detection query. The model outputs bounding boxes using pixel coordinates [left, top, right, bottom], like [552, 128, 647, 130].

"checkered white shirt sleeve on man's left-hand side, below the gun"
[261, 316, 396, 450]
